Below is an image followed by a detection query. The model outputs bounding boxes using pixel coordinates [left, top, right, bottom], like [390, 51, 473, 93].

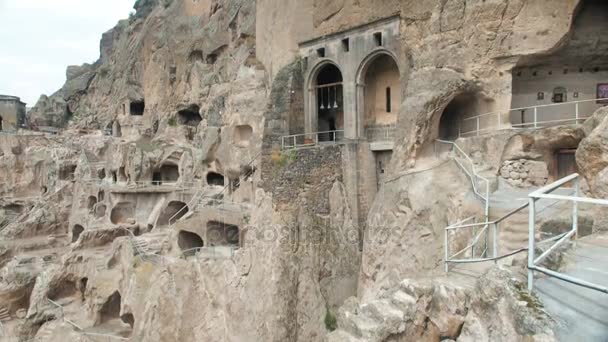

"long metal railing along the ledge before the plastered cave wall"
[458, 98, 608, 137]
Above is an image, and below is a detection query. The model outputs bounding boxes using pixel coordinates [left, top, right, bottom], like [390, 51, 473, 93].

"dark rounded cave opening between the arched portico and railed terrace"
[437, 92, 484, 141]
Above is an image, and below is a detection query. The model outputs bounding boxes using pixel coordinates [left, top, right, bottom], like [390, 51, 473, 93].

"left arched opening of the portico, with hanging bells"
[315, 64, 344, 141]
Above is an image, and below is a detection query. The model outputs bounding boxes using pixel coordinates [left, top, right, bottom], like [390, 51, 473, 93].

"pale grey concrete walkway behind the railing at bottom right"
[535, 234, 608, 342]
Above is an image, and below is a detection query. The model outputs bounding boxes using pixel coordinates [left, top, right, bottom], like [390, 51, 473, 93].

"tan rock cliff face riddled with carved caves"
[0, 0, 606, 341]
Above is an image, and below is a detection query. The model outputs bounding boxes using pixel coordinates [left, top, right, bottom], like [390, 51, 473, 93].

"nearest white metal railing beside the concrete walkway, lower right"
[528, 173, 608, 293]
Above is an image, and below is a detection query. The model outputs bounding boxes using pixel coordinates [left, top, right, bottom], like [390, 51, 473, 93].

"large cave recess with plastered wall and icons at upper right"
[509, 0, 608, 128]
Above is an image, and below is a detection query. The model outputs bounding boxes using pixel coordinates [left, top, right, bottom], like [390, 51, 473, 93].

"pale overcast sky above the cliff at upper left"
[0, 0, 135, 107]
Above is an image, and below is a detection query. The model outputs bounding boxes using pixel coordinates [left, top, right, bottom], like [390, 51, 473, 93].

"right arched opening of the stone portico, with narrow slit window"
[358, 51, 401, 140]
